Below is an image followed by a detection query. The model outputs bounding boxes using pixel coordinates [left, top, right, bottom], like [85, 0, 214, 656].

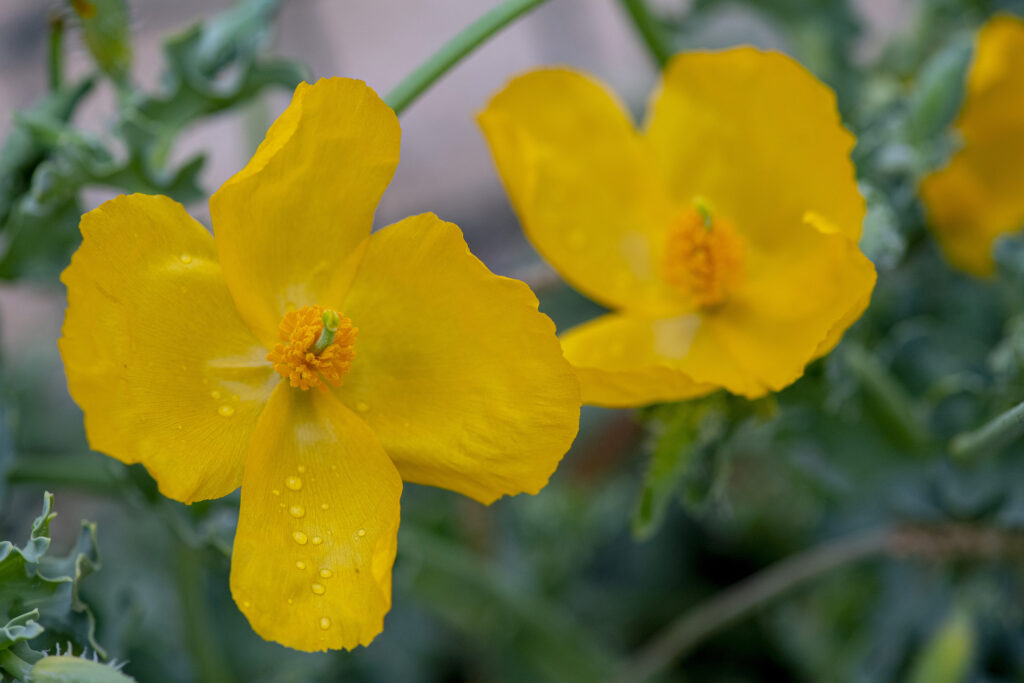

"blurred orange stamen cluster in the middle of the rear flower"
[662, 203, 745, 308]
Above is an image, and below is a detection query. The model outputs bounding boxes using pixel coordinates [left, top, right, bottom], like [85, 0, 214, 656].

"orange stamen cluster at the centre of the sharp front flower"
[266, 306, 358, 391]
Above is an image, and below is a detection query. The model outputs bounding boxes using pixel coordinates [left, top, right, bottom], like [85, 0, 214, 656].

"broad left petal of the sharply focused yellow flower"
[60, 195, 276, 503]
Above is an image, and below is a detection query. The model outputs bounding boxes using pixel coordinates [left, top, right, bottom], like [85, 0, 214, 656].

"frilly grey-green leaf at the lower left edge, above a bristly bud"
[0, 493, 103, 655]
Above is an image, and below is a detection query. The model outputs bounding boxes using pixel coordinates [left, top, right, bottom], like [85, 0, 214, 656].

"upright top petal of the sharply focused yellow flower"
[210, 78, 400, 345]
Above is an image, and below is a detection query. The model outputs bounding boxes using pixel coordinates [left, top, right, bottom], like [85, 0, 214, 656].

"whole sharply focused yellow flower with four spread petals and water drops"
[60, 79, 580, 650]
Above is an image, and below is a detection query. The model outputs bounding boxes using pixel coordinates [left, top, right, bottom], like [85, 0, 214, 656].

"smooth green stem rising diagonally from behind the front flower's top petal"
[384, 0, 547, 114]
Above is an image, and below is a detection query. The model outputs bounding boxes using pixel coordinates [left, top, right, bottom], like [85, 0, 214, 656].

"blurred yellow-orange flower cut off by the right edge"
[921, 15, 1024, 276]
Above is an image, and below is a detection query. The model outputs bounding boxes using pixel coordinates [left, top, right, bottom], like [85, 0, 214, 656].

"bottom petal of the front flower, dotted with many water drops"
[230, 383, 401, 651]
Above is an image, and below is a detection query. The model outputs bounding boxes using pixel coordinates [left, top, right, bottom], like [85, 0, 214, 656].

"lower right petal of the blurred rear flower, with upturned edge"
[707, 217, 876, 391]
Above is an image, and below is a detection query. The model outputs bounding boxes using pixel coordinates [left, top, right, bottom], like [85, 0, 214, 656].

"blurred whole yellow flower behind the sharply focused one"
[479, 48, 874, 405]
